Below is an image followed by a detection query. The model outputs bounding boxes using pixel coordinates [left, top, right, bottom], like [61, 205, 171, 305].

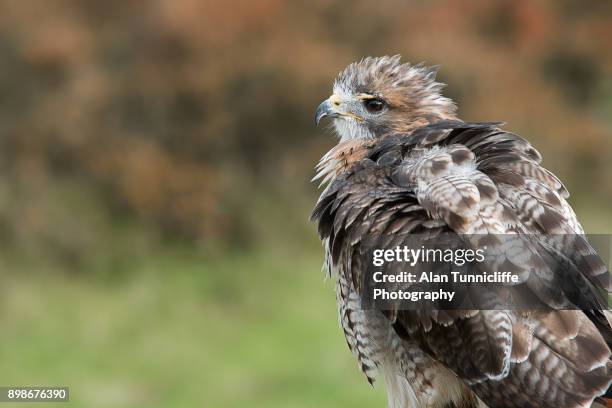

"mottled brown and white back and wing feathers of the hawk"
[312, 120, 612, 408]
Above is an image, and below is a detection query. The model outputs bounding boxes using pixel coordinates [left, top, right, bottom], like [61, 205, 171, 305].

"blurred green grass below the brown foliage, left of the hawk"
[0, 245, 384, 407]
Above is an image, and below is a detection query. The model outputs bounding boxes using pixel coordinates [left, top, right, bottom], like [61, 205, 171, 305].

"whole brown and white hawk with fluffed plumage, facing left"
[312, 56, 612, 408]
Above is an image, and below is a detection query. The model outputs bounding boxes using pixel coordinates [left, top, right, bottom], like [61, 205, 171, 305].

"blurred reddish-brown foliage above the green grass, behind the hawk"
[0, 0, 612, 251]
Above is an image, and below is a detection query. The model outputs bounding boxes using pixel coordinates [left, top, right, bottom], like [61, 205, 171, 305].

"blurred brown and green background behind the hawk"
[0, 0, 612, 407]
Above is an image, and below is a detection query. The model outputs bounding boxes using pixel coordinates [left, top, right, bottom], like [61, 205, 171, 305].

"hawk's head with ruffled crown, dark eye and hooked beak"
[315, 55, 456, 141]
